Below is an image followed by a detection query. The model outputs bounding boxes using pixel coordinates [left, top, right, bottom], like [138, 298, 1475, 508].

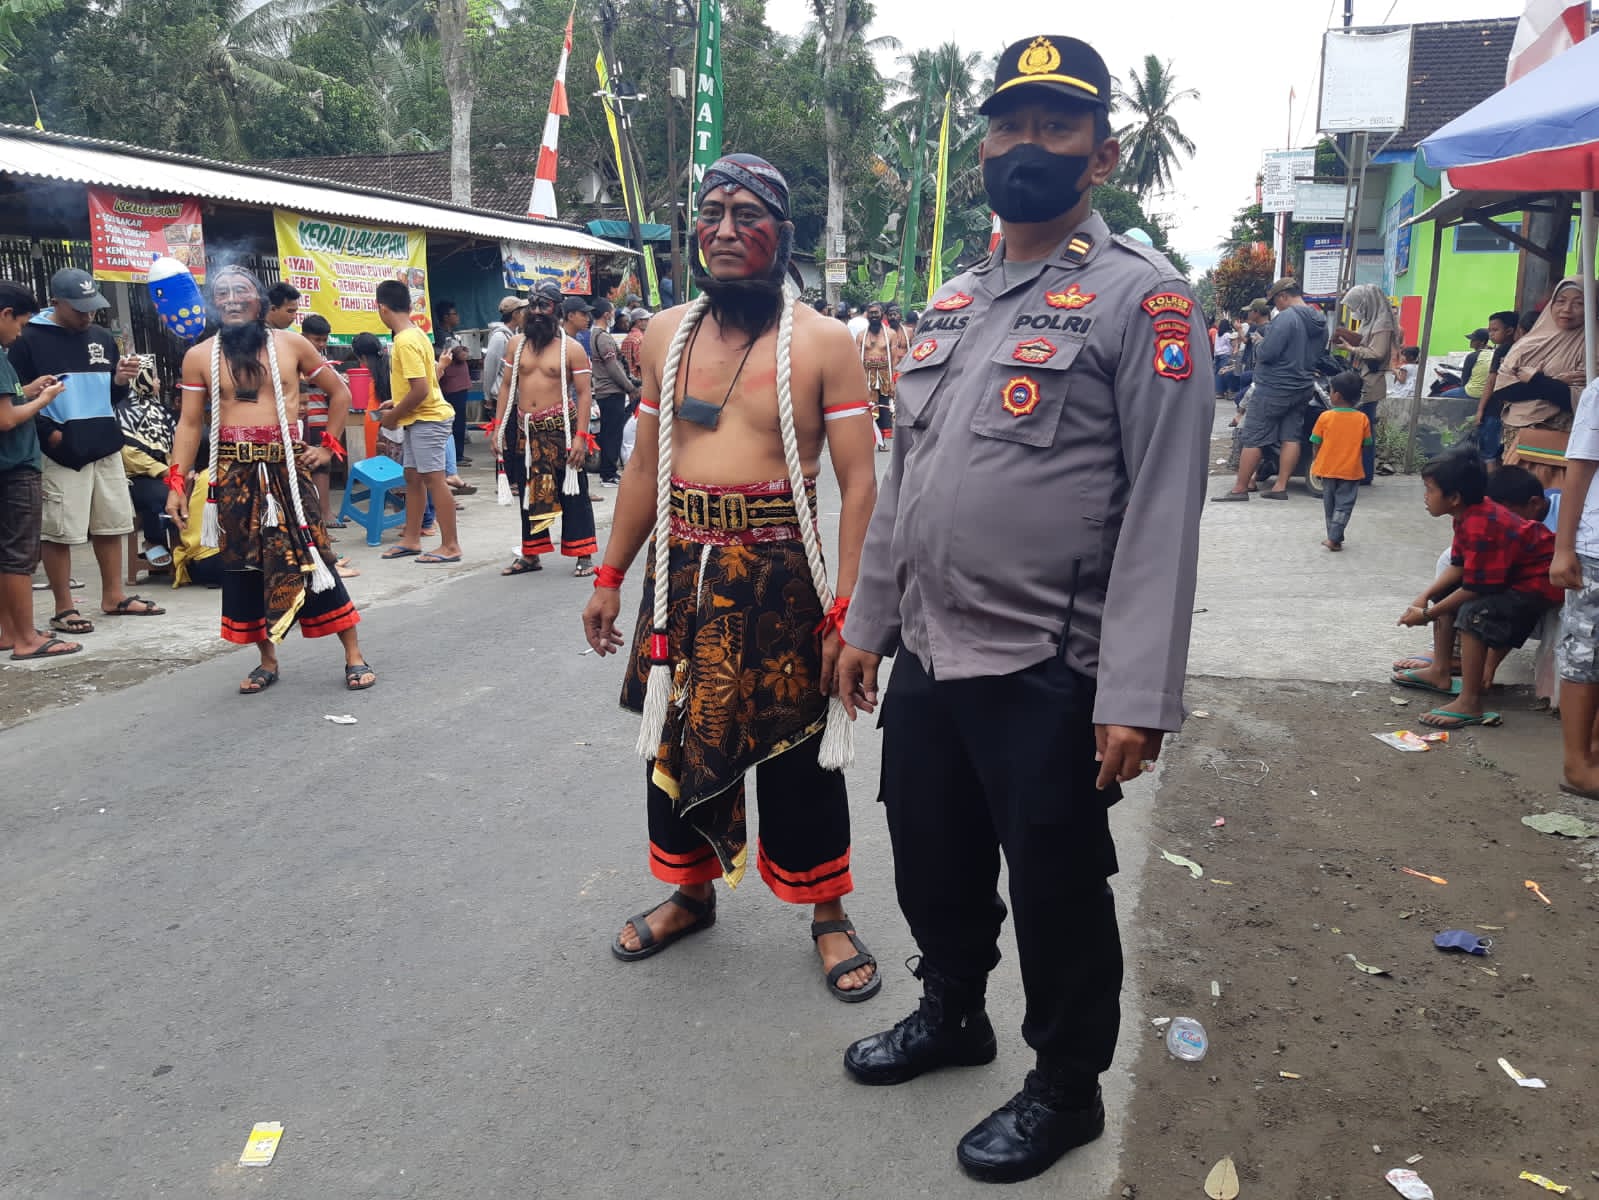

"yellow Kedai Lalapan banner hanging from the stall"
[272, 210, 433, 338]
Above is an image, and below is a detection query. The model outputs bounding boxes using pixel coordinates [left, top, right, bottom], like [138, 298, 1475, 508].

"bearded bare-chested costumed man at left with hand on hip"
[166, 267, 377, 696]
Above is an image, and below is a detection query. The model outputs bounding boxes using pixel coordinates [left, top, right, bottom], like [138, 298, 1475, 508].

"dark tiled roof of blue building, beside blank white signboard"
[1388, 16, 1517, 150]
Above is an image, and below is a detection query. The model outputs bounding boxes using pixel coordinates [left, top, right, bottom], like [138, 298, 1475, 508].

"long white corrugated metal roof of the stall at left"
[0, 125, 633, 254]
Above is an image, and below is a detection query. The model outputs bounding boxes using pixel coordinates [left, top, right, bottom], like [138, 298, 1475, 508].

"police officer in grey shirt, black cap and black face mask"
[839, 37, 1214, 1182]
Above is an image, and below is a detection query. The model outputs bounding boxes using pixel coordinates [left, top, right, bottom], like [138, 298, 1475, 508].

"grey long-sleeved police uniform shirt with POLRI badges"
[844, 213, 1215, 730]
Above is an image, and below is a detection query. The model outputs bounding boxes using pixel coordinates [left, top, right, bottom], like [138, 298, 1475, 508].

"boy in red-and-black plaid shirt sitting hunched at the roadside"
[1393, 454, 1565, 730]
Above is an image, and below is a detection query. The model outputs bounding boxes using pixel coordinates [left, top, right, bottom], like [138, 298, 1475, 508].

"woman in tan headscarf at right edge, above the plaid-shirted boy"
[1493, 275, 1591, 466]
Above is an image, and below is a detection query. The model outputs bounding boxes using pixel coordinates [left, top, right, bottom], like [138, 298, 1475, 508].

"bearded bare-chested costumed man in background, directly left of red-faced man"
[494, 280, 598, 578]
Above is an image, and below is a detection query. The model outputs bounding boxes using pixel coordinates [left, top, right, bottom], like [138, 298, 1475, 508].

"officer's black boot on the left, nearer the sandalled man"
[844, 960, 999, 1083]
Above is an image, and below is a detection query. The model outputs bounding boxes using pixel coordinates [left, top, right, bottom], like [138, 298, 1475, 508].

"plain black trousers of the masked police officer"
[879, 651, 1121, 1091]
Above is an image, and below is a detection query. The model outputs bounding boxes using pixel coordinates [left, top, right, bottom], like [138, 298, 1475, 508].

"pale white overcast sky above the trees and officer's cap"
[766, 0, 1525, 272]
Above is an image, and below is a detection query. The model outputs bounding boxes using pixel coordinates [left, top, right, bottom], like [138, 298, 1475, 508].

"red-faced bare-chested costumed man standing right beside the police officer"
[584, 154, 881, 1002]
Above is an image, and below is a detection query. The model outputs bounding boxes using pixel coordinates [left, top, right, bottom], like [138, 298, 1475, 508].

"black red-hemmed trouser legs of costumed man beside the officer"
[644, 736, 855, 904]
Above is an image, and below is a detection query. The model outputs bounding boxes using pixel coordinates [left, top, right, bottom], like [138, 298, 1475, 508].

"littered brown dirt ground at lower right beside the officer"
[1121, 678, 1599, 1200]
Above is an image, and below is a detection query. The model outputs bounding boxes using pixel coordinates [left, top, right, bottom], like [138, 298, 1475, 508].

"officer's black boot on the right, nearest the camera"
[955, 1070, 1105, 1184]
